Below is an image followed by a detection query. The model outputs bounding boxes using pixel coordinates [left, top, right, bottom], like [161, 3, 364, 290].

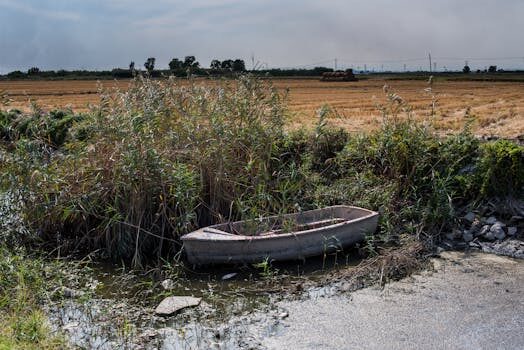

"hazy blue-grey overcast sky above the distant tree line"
[0, 0, 524, 73]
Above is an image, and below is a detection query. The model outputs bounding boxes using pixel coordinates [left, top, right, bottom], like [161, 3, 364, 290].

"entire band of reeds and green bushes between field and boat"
[0, 76, 524, 266]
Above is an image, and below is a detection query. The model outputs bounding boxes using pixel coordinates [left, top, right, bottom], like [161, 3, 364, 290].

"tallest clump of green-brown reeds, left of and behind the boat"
[5, 77, 304, 265]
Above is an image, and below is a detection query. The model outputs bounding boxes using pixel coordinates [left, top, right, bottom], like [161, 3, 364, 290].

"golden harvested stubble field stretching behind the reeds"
[0, 79, 524, 138]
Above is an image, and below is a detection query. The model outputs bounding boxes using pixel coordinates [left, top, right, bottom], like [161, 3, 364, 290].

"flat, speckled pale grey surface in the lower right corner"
[262, 253, 524, 350]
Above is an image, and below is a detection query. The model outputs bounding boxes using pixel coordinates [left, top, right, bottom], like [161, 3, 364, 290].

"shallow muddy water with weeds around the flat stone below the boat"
[48, 251, 359, 349]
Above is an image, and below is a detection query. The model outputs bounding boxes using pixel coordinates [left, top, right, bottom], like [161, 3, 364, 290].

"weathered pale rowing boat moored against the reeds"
[182, 205, 378, 265]
